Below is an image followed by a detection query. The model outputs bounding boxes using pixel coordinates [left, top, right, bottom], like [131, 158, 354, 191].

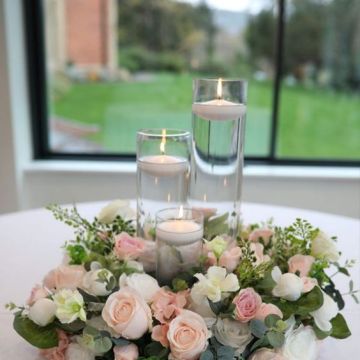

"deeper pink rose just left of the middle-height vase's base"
[114, 232, 145, 260]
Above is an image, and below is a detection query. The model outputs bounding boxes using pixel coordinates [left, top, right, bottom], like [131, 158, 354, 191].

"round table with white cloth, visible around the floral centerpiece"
[0, 202, 360, 360]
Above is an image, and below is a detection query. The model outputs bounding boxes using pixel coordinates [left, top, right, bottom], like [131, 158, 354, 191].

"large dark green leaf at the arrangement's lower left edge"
[13, 314, 58, 349]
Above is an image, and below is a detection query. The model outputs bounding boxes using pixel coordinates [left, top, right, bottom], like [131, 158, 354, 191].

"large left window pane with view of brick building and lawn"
[43, 0, 276, 156]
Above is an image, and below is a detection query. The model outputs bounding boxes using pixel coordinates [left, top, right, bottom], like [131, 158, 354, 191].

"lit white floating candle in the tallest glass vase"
[192, 78, 246, 121]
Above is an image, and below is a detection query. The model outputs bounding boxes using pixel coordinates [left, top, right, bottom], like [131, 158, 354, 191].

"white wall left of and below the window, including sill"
[0, 0, 360, 218]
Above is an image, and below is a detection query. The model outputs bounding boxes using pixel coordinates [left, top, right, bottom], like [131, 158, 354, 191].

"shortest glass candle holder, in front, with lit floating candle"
[155, 206, 204, 285]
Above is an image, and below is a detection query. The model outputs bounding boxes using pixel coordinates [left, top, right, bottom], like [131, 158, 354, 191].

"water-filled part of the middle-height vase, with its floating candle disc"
[137, 155, 189, 239]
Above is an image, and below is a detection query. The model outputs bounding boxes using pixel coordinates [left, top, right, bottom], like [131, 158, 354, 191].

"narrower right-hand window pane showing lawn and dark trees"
[277, 0, 360, 159]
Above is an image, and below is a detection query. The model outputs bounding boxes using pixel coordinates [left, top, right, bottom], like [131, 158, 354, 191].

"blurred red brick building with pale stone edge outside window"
[44, 0, 117, 72]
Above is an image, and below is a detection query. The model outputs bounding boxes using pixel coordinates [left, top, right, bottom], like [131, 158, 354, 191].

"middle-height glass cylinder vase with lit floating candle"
[137, 129, 191, 239]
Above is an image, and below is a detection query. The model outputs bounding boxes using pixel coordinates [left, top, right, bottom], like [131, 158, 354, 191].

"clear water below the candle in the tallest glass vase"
[189, 113, 246, 239]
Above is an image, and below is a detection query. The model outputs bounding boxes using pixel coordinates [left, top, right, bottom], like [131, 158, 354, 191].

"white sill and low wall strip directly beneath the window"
[22, 162, 360, 218]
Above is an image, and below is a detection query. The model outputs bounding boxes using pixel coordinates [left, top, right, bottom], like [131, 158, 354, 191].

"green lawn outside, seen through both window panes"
[52, 74, 360, 159]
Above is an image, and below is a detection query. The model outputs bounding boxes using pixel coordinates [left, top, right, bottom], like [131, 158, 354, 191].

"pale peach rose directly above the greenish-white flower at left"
[43, 265, 86, 290]
